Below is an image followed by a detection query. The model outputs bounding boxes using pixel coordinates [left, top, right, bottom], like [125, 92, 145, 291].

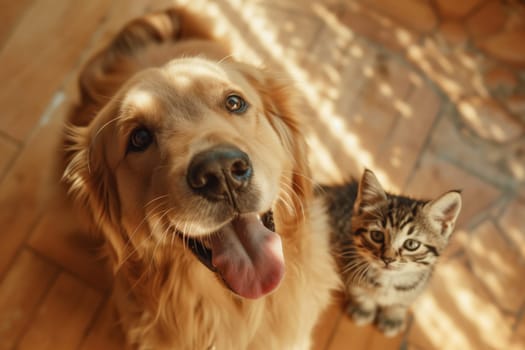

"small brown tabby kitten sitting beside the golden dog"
[320, 170, 461, 336]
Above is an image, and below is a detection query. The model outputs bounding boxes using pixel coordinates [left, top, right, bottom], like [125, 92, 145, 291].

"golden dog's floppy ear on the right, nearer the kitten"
[239, 64, 313, 223]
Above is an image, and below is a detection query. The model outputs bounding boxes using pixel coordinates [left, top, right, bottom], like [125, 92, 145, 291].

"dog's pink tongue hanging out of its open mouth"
[211, 214, 284, 299]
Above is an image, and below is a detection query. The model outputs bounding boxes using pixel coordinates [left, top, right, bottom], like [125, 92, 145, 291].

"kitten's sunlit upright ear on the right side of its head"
[424, 191, 461, 237]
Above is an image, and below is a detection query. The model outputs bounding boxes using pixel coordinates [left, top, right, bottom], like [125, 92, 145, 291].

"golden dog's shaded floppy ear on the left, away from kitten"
[62, 107, 125, 262]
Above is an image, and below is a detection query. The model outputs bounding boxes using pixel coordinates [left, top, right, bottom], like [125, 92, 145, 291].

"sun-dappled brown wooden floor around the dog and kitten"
[0, 0, 525, 350]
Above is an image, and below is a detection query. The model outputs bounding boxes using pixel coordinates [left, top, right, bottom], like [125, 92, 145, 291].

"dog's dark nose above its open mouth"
[186, 145, 253, 200]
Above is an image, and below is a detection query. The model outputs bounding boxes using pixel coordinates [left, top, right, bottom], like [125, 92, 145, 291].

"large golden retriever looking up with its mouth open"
[64, 10, 338, 350]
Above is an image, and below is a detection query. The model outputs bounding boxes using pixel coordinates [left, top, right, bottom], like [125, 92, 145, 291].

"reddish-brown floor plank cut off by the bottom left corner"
[0, 250, 57, 350]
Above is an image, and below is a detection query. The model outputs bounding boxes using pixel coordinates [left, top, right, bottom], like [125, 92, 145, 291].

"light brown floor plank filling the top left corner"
[0, 0, 110, 141]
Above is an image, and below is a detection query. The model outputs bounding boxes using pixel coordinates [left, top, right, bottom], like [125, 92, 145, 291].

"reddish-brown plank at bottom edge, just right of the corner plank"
[18, 273, 102, 350]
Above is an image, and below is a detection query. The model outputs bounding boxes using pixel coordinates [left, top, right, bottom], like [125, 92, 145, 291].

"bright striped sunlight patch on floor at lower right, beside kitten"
[413, 262, 510, 349]
